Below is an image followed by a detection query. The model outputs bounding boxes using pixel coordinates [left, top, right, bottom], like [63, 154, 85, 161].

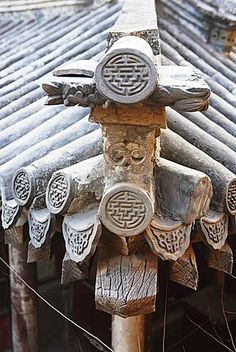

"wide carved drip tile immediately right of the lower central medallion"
[145, 219, 192, 260]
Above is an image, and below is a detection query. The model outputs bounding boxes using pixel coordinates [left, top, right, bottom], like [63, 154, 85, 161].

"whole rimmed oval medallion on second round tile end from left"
[46, 174, 70, 214]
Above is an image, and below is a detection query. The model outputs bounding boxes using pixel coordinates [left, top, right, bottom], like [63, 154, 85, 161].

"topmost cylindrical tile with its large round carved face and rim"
[95, 36, 157, 104]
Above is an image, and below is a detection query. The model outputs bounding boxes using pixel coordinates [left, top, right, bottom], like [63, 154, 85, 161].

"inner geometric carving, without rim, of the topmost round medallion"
[102, 54, 150, 96]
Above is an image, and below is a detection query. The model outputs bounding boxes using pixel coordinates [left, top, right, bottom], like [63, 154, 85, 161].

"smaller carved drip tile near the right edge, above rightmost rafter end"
[199, 211, 229, 249]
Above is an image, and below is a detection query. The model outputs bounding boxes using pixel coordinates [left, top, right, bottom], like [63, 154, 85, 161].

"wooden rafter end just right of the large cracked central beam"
[170, 245, 199, 290]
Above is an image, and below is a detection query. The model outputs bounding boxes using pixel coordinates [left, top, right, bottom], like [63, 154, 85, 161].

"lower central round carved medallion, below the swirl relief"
[99, 183, 154, 236]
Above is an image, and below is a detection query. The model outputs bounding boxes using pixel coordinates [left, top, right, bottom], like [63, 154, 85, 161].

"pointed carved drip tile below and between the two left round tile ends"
[29, 209, 51, 248]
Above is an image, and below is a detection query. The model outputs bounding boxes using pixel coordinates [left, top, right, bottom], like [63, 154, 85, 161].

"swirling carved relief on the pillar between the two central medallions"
[108, 142, 146, 167]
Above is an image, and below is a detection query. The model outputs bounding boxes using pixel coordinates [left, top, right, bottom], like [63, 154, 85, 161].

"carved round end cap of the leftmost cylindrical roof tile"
[13, 169, 32, 205]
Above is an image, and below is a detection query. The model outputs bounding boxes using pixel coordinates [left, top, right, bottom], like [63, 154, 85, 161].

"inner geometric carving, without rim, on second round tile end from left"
[47, 175, 68, 208]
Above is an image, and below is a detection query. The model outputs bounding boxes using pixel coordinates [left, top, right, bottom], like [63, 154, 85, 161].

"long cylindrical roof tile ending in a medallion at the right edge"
[161, 129, 235, 214]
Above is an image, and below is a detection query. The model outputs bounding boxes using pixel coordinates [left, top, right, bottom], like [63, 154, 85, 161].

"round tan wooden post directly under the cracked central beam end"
[112, 315, 145, 352]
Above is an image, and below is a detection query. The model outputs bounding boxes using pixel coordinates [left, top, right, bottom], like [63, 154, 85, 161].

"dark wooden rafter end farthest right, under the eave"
[208, 242, 234, 275]
